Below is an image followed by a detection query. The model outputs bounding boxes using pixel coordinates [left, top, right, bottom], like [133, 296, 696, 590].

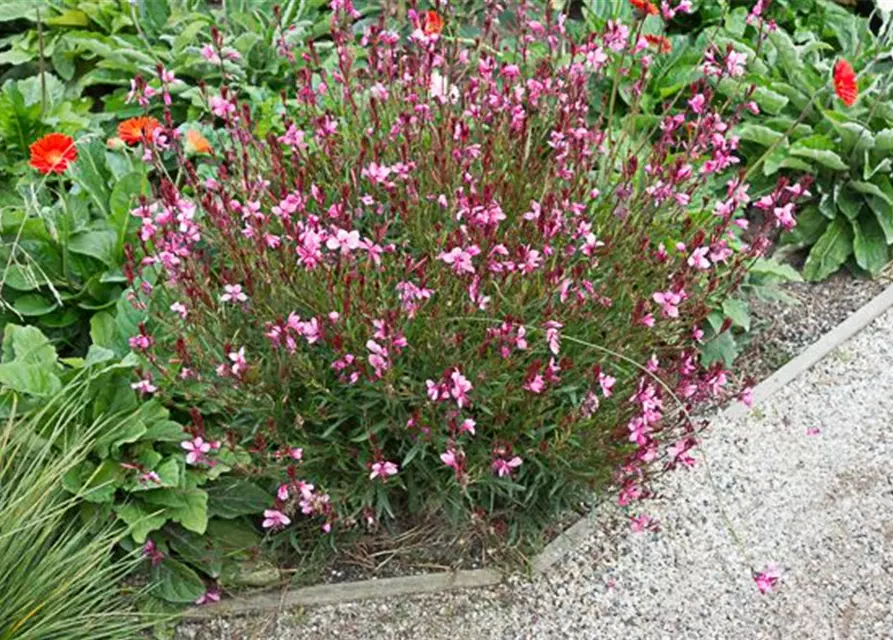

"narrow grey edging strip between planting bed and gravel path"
[184, 285, 893, 619]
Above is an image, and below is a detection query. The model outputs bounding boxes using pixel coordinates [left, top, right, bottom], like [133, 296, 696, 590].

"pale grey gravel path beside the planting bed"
[179, 310, 893, 640]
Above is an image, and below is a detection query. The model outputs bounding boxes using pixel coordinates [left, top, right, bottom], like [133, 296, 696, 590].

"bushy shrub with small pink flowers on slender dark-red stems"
[127, 0, 805, 552]
